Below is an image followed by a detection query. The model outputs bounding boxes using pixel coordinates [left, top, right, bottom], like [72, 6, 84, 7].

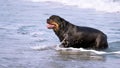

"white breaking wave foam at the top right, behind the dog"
[31, 0, 120, 12]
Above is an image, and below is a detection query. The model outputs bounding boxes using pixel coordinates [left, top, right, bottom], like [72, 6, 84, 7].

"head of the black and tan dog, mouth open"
[47, 15, 66, 31]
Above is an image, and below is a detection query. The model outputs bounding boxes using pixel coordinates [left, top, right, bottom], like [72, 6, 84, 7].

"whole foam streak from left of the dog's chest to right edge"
[31, 45, 120, 55]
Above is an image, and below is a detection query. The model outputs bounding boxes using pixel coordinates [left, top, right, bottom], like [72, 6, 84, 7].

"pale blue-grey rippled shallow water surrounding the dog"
[0, 0, 120, 68]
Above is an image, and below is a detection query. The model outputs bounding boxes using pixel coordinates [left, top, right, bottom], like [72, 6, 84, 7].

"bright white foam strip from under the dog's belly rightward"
[56, 47, 120, 55]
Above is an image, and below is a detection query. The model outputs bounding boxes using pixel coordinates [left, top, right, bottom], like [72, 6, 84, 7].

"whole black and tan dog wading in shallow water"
[47, 15, 108, 50]
